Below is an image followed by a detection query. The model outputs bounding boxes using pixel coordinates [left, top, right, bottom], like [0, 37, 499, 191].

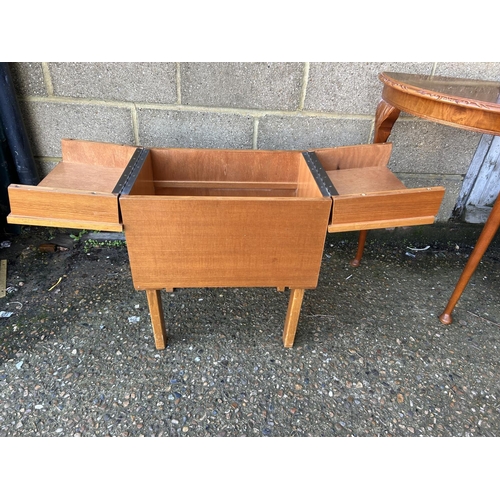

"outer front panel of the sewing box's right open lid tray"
[328, 187, 445, 232]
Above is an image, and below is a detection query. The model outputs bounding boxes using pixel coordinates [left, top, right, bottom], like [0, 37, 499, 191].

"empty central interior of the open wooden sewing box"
[120, 148, 321, 198]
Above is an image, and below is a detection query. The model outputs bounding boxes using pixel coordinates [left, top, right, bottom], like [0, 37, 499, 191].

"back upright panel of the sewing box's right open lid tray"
[314, 142, 392, 171]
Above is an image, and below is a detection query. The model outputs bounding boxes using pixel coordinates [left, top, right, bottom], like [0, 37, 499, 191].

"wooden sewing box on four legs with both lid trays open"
[7, 139, 444, 349]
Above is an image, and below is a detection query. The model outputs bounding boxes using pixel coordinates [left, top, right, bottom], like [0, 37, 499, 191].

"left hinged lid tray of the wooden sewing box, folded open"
[7, 139, 143, 231]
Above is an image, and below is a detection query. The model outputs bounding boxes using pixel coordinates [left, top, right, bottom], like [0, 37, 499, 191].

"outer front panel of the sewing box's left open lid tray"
[8, 184, 122, 231]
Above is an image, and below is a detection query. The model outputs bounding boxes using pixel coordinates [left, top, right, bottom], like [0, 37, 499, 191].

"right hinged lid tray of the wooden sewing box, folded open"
[306, 143, 445, 232]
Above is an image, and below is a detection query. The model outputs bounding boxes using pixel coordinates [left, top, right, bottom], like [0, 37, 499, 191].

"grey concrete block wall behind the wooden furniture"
[10, 62, 500, 221]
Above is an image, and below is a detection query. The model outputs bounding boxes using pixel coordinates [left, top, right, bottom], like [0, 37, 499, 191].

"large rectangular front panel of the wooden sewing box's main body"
[120, 195, 331, 289]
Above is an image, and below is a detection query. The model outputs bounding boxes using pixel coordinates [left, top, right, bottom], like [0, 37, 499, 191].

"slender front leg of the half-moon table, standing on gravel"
[439, 196, 500, 325]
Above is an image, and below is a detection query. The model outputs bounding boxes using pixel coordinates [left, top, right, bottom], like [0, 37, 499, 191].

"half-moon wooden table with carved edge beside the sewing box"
[368, 73, 500, 324]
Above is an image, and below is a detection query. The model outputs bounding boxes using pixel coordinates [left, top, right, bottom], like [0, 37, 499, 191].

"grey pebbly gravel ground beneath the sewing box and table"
[0, 224, 500, 437]
